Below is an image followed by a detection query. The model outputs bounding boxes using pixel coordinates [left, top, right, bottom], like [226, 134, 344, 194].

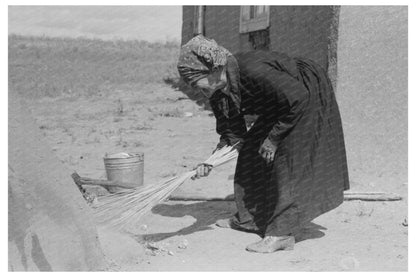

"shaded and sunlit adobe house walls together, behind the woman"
[182, 6, 408, 190]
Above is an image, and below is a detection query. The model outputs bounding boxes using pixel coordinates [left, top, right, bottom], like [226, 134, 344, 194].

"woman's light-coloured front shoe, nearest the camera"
[246, 236, 295, 253]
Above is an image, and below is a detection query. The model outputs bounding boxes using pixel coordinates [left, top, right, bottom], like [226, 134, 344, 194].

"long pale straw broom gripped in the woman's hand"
[94, 144, 238, 229]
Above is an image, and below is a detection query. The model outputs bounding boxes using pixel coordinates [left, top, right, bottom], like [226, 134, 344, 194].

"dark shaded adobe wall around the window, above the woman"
[182, 6, 333, 68]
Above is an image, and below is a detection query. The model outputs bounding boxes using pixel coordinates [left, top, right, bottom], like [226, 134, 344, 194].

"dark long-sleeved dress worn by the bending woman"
[212, 51, 349, 236]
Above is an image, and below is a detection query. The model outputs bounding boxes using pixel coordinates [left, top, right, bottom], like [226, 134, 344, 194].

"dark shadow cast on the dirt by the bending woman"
[140, 201, 326, 242]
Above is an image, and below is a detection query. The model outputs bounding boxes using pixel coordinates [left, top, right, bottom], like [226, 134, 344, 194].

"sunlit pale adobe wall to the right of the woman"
[337, 6, 408, 190]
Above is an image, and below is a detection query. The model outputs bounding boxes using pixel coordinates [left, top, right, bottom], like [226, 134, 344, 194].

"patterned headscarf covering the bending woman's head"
[178, 35, 231, 85]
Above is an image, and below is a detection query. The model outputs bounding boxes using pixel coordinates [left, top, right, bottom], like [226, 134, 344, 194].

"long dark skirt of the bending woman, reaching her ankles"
[234, 57, 349, 236]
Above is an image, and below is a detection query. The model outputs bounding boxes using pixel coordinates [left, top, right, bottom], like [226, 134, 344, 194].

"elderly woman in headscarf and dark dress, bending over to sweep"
[178, 35, 349, 253]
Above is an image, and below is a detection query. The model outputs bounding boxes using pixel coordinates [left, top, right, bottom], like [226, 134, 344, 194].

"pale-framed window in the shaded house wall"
[240, 6, 270, 33]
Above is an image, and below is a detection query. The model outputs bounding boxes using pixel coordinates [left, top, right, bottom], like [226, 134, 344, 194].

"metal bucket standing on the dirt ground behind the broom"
[104, 153, 144, 192]
